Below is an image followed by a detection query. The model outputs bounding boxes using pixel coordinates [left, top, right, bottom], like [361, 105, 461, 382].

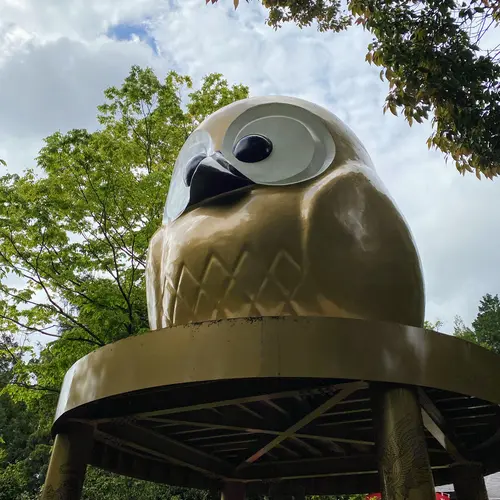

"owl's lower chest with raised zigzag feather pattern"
[164, 241, 306, 324]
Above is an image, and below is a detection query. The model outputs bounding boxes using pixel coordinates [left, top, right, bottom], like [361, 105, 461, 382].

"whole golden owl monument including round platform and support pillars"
[42, 96, 500, 500]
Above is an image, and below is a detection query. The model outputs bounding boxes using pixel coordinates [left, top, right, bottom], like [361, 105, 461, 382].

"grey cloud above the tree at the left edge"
[0, 37, 156, 137]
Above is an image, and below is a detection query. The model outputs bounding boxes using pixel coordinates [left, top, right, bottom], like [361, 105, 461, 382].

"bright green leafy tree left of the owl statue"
[0, 66, 248, 500]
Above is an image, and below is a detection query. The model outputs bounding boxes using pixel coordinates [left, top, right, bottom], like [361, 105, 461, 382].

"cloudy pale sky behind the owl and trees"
[0, 0, 500, 332]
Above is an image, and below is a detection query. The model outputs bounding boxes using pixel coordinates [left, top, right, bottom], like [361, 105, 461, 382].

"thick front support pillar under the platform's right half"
[370, 384, 436, 500]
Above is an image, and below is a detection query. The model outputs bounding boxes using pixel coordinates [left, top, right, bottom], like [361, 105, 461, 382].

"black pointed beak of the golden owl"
[186, 153, 254, 207]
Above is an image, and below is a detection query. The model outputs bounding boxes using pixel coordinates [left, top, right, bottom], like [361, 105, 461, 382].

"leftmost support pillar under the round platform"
[41, 424, 93, 500]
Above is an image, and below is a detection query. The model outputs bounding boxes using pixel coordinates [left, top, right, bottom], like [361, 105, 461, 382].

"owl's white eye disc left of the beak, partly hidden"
[163, 130, 213, 222]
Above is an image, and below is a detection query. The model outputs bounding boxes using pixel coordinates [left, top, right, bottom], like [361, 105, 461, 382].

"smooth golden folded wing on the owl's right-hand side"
[302, 166, 424, 325]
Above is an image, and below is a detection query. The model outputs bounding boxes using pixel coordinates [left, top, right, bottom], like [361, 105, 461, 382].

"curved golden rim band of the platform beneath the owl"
[56, 317, 500, 420]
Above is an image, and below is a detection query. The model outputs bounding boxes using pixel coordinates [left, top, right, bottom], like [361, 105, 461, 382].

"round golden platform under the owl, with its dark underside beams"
[53, 317, 500, 495]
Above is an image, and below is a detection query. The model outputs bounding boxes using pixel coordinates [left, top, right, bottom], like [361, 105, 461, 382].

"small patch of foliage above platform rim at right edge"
[454, 293, 500, 354]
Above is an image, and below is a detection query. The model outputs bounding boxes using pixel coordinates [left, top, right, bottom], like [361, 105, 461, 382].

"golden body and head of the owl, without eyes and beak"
[146, 96, 424, 330]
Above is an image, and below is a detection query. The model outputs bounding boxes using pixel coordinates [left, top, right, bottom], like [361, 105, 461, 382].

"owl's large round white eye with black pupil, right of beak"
[222, 103, 335, 186]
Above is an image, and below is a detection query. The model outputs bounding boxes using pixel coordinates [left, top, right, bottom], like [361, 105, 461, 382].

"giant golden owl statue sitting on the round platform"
[146, 96, 424, 330]
